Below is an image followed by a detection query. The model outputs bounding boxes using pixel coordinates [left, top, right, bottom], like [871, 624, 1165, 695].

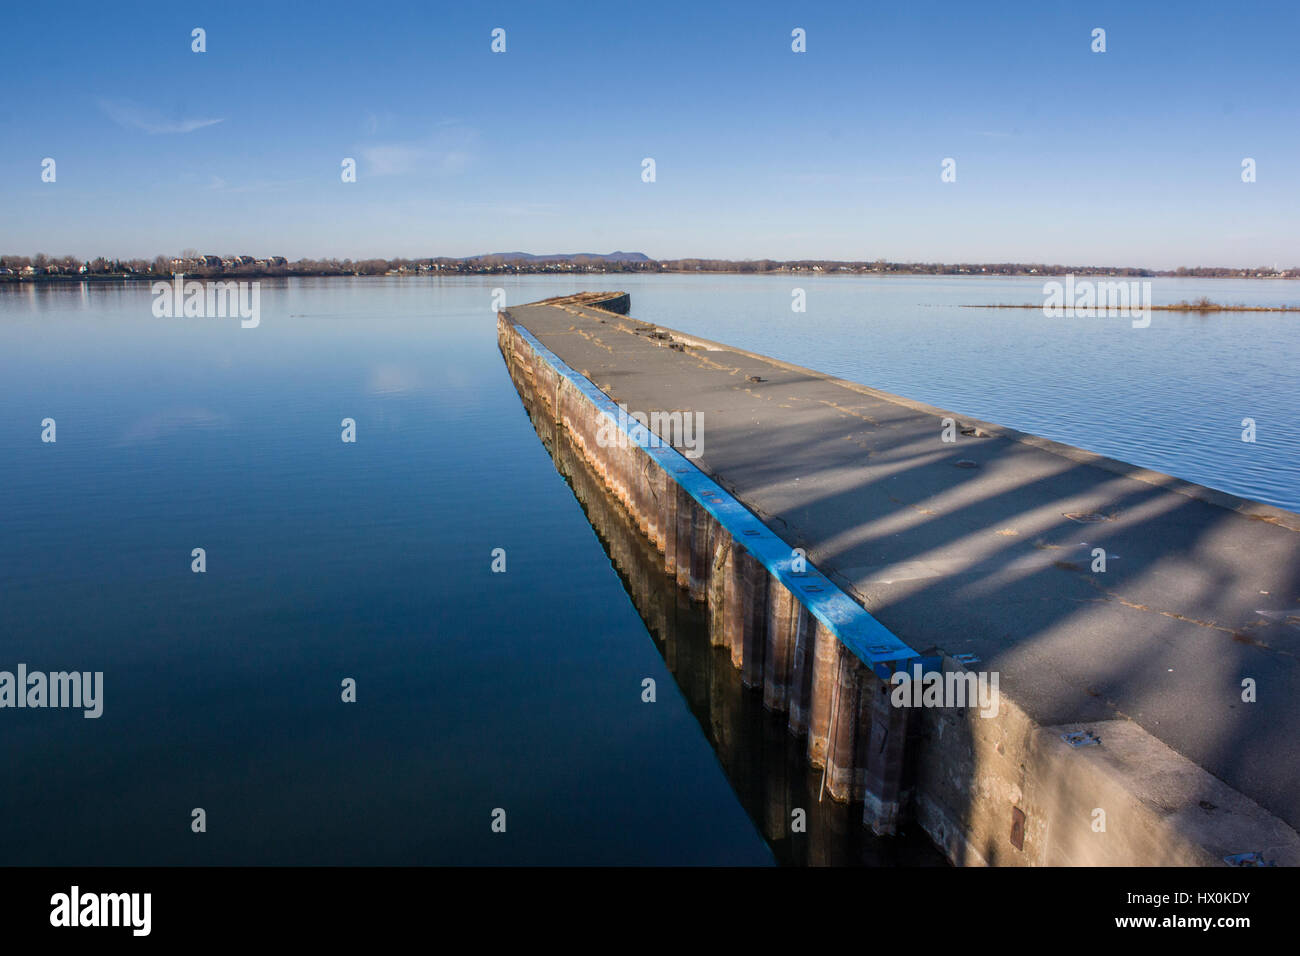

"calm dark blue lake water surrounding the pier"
[0, 276, 1300, 865]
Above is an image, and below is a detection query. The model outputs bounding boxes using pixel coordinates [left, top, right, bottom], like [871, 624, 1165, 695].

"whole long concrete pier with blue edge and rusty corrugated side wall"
[498, 294, 1300, 865]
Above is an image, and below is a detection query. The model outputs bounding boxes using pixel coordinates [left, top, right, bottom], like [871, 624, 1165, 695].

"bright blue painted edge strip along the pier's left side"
[508, 319, 937, 680]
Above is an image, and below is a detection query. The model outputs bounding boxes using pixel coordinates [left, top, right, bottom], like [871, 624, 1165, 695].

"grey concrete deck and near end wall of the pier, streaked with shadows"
[501, 294, 1300, 865]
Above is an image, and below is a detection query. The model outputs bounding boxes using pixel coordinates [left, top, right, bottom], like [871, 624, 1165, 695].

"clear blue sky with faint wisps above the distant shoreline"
[0, 0, 1300, 268]
